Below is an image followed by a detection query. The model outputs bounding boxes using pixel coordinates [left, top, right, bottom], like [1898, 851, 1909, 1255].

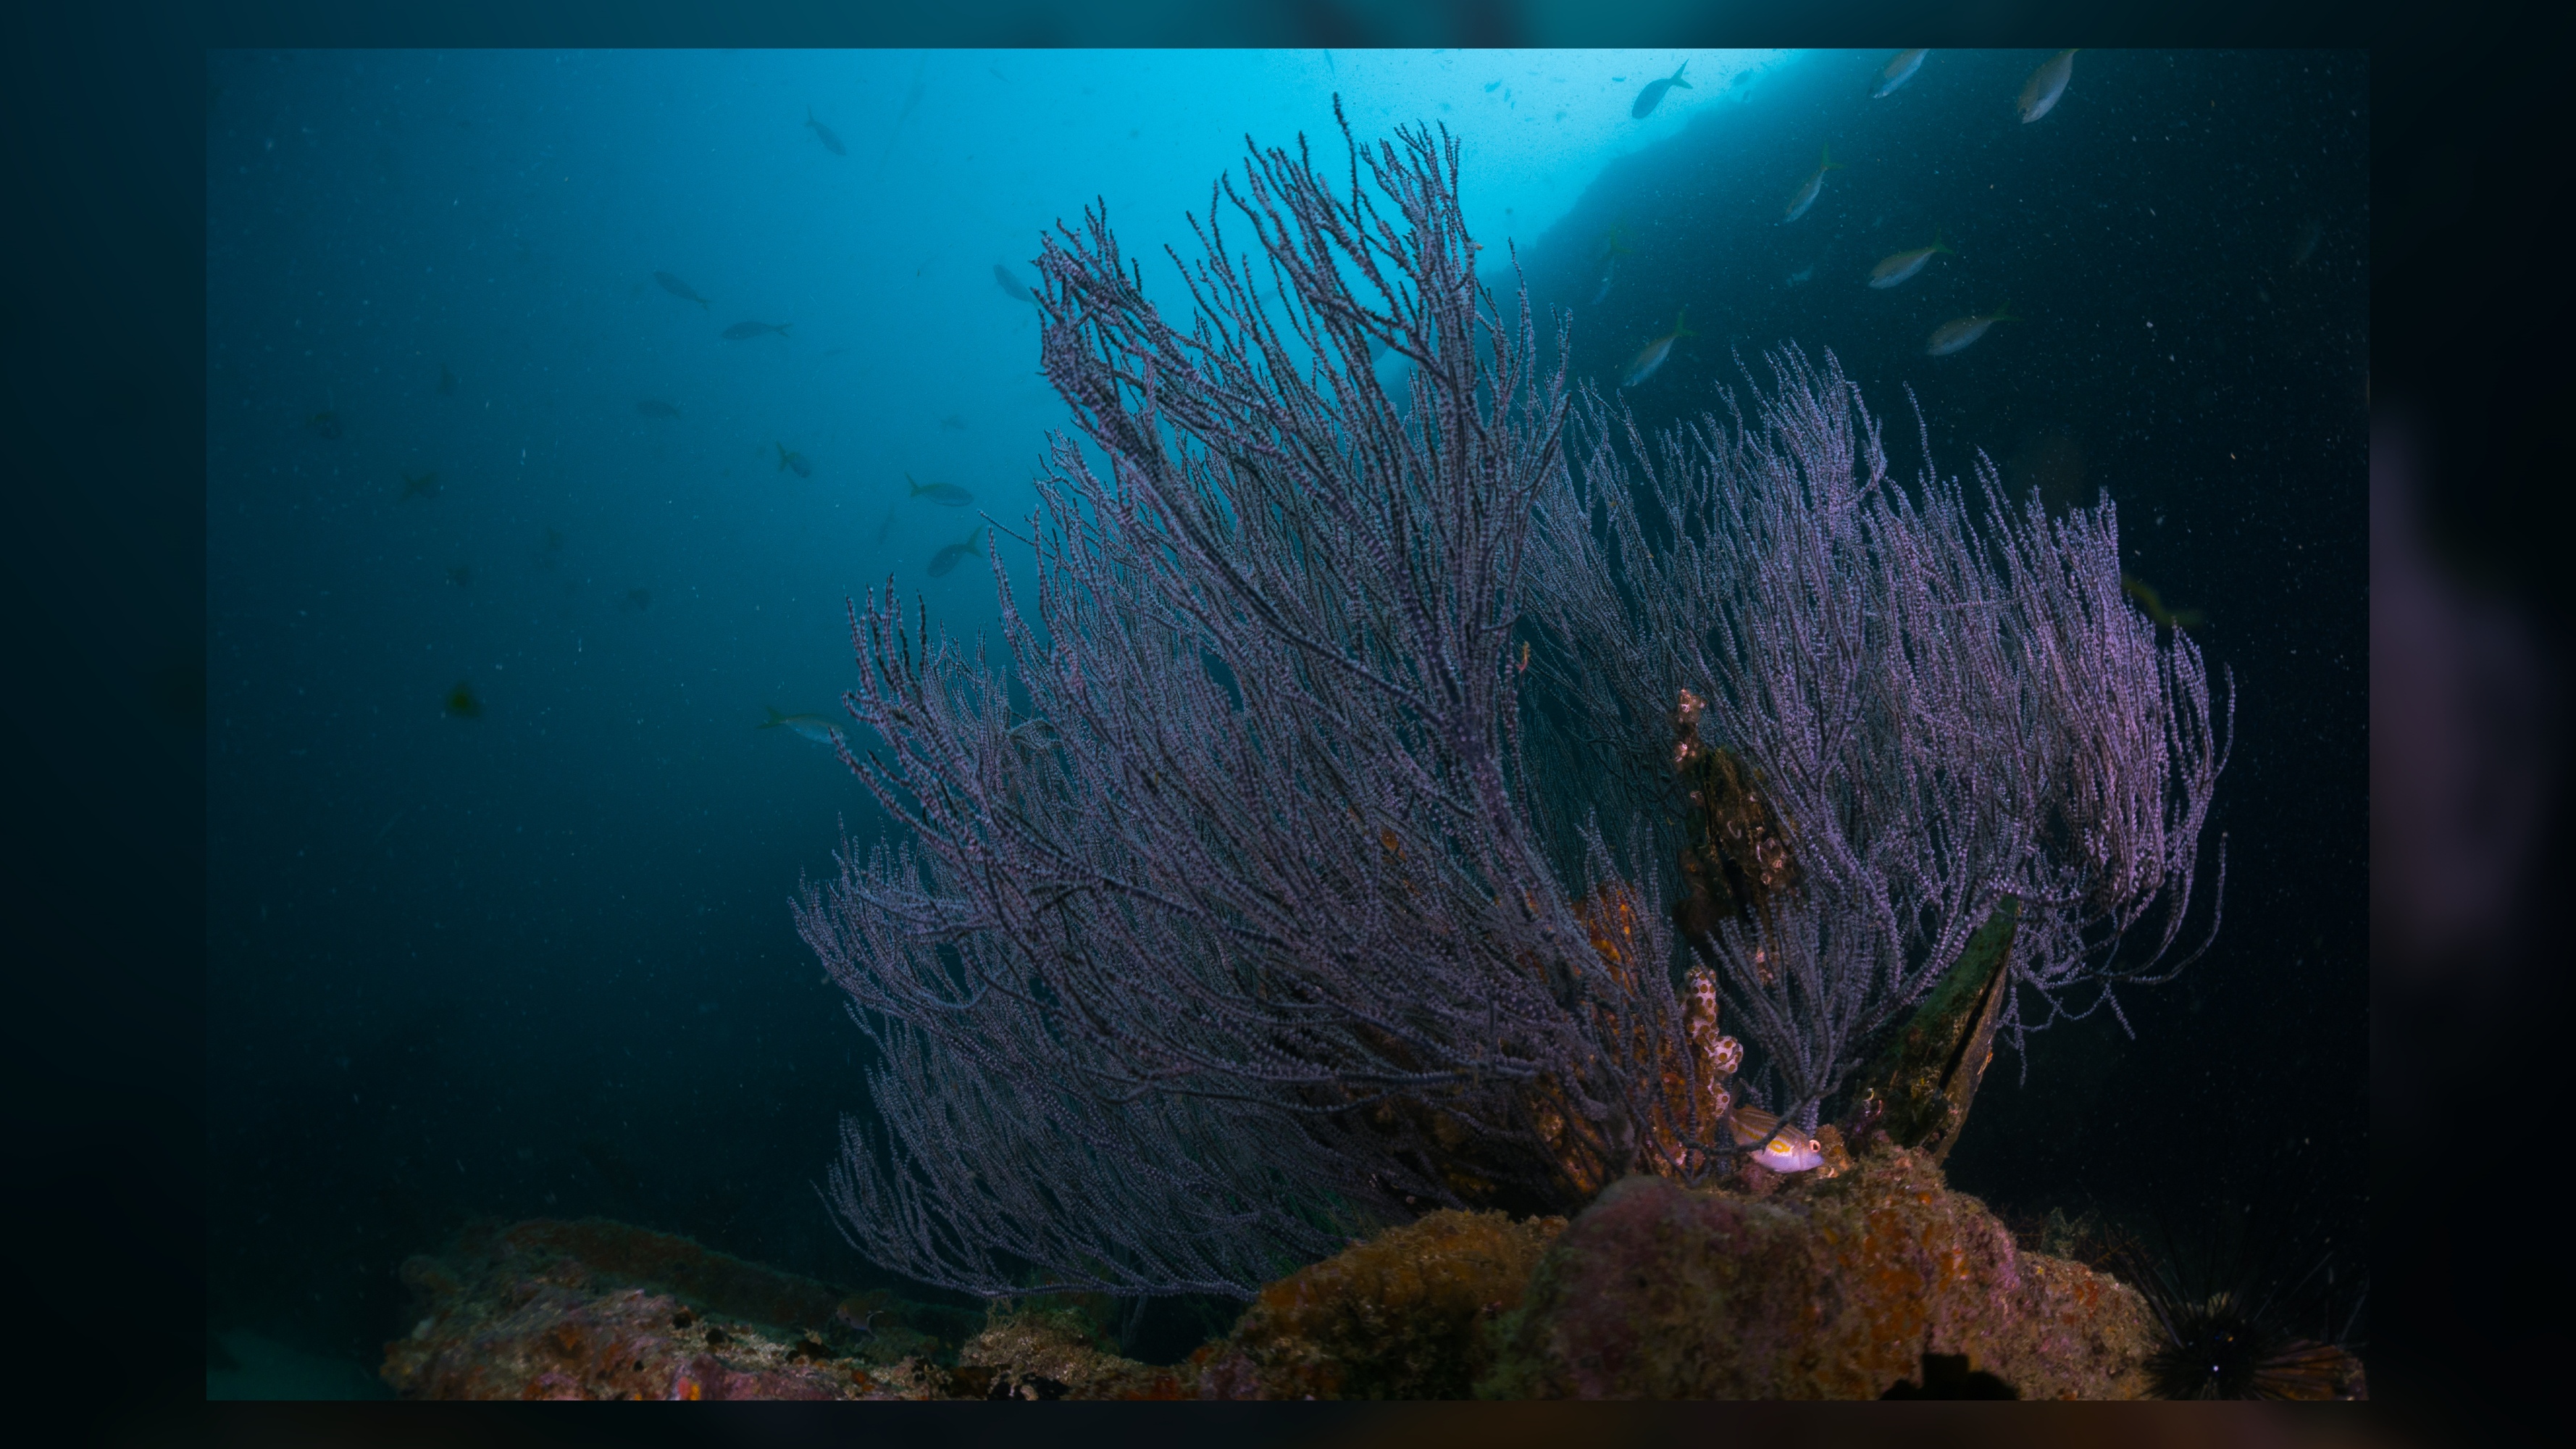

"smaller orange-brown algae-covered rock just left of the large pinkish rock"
[1190, 1209, 1566, 1400]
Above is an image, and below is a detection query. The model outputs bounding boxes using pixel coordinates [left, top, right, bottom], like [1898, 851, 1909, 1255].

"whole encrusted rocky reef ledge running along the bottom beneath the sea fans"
[384, 1135, 2215, 1400]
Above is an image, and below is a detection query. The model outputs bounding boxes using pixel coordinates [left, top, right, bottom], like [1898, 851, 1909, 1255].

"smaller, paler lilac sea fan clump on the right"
[1525, 348, 2233, 1124]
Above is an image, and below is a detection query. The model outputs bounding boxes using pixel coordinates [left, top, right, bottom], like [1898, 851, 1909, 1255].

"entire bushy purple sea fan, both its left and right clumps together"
[796, 107, 2218, 1297]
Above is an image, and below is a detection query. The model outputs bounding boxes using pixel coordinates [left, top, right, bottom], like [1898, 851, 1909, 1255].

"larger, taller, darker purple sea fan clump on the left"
[798, 104, 1718, 1294]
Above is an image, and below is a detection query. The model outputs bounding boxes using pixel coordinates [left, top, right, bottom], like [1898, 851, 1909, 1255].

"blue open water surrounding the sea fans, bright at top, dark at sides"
[206, 51, 2367, 1392]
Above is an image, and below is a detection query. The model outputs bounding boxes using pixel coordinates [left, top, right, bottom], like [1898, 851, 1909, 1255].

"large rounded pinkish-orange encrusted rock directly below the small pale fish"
[1479, 1148, 2154, 1398]
